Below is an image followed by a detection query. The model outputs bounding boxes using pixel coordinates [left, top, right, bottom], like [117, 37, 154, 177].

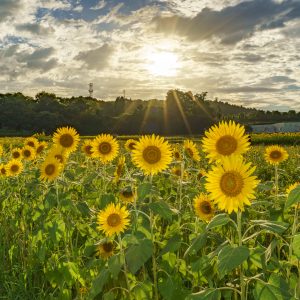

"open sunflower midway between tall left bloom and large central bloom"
[92, 134, 119, 164]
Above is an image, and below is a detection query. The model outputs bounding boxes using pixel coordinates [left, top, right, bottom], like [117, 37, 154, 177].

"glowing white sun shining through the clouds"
[146, 50, 179, 77]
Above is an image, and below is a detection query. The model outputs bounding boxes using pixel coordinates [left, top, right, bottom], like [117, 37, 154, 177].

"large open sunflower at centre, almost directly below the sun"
[132, 134, 172, 175]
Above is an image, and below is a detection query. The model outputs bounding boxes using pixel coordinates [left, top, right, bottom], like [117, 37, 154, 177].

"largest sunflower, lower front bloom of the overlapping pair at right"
[205, 155, 259, 213]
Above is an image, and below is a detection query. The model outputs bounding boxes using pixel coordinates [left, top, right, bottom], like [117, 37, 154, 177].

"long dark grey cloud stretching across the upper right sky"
[152, 0, 300, 44]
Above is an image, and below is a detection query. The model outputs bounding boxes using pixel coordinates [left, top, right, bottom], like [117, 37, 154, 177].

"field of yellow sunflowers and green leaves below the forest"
[0, 121, 300, 300]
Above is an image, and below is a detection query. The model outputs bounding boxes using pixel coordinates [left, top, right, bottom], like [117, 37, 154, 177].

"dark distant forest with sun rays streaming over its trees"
[0, 90, 300, 136]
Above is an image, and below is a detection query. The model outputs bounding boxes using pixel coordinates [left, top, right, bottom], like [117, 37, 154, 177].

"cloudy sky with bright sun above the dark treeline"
[0, 0, 300, 111]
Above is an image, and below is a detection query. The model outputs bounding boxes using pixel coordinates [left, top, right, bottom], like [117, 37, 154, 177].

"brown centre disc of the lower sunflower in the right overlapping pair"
[220, 172, 244, 197]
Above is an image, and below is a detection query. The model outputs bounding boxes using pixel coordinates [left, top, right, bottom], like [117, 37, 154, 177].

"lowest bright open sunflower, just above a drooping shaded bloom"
[97, 203, 129, 236]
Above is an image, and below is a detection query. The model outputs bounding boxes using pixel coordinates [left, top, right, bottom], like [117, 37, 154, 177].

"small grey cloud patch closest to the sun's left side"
[75, 44, 113, 70]
